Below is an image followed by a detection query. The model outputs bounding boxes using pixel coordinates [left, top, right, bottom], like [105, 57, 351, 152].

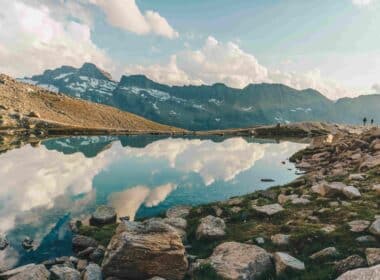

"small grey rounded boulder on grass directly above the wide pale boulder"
[196, 215, 226, 240]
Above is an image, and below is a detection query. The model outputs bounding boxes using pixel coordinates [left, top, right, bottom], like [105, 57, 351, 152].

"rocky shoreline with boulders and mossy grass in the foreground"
[0, 129, 380, 280]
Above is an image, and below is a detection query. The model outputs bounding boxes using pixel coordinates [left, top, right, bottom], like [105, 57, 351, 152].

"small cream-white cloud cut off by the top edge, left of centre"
[89, 0, 178, 39]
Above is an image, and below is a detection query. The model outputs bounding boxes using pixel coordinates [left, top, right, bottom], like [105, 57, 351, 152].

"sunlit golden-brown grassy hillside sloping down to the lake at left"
[0, 75, 180, 132]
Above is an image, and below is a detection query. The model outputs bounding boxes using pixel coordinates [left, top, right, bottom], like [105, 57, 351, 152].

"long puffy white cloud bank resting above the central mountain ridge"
[125, 37, 352, 99]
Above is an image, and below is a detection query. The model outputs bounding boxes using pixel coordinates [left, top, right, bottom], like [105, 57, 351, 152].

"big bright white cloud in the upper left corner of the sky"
[0, 0, 112, 76]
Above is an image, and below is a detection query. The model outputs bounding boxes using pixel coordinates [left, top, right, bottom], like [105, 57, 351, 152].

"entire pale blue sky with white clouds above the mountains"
[0, 0, 380, 99]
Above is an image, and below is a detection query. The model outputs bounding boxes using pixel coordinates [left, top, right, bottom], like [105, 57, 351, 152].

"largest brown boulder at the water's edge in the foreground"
[102, 219, 188, 280]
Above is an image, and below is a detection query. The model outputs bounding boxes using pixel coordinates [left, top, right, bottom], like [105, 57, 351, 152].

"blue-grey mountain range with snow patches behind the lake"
[20, 63, 380, 130]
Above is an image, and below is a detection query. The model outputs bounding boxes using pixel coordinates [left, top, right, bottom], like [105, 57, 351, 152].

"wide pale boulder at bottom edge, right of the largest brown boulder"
[208, 242, 273, 280]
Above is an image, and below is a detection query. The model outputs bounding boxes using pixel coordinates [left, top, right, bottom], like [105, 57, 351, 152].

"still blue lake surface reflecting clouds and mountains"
[0, 136, 305, 269]
